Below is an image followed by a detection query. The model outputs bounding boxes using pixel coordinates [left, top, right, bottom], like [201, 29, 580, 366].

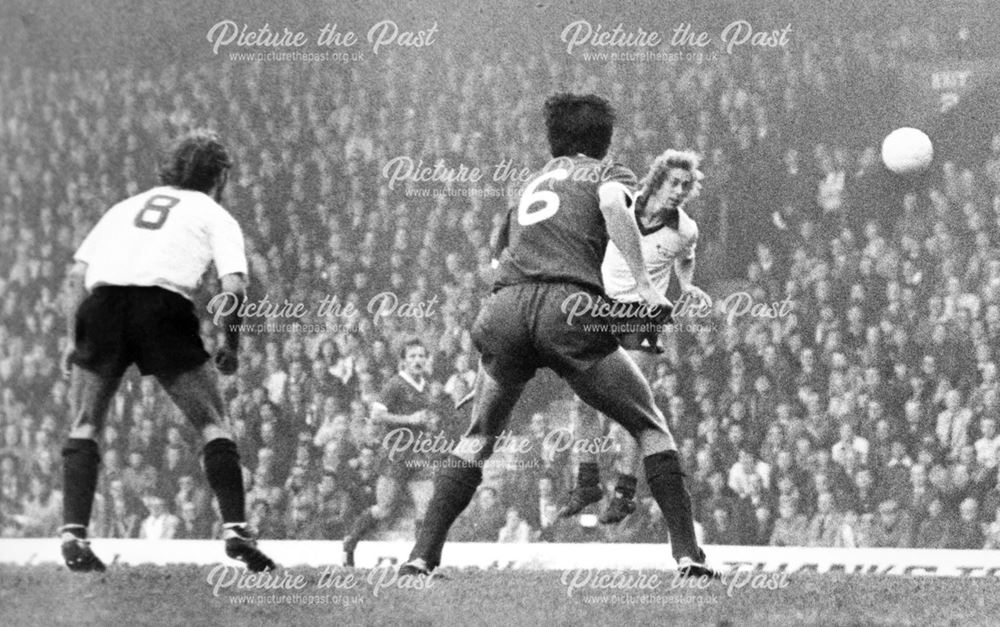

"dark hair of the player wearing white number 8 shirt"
[160, 129, 233, 193]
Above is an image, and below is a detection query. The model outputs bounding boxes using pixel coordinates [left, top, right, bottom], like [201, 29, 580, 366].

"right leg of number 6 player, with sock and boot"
[567, 348, 716, 576]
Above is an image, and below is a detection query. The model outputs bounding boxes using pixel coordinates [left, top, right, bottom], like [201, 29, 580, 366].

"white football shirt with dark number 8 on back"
[73, 186, 247, 298]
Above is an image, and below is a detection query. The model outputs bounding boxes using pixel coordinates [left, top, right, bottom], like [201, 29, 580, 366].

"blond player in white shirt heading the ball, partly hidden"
[559, 150, 712, 524]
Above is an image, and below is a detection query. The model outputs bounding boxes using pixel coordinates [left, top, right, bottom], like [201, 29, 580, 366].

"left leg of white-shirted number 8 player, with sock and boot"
[59, 365, 121, 571]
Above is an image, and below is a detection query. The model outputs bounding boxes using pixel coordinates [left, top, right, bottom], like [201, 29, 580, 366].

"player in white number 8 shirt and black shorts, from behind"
[60, 131, 275, 571]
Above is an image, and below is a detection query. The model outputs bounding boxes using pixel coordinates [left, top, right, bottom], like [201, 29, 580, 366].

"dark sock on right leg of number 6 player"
[643, 451, 701, 561]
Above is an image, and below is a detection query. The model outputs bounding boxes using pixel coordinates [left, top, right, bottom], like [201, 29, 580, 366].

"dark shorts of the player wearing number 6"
[472, 283, 618, 382]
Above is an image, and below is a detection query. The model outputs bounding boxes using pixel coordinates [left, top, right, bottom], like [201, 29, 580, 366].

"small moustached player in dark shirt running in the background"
[343, 340, 433, 566]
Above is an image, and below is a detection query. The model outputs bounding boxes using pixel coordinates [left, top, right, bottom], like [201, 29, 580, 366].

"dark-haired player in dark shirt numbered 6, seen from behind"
[400, 94, 717, 577]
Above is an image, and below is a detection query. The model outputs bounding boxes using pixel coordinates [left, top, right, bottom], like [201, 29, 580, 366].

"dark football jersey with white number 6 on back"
[495, 155, 636, 293]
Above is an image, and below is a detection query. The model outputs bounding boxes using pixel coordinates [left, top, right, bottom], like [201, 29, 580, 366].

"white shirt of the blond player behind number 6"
[601, 209, 698, 303]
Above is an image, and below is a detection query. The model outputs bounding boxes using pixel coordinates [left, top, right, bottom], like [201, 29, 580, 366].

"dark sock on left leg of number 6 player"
[410, 457, 483, 569]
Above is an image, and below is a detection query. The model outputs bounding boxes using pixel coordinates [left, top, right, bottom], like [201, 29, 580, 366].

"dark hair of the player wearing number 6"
[545, 93, 615, 159]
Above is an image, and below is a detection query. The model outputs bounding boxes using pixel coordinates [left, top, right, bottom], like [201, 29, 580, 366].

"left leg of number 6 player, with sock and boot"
[399, 365, 525, 575]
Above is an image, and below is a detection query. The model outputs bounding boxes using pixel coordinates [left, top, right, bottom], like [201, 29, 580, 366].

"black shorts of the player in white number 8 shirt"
[70, 286, 209, 377]
